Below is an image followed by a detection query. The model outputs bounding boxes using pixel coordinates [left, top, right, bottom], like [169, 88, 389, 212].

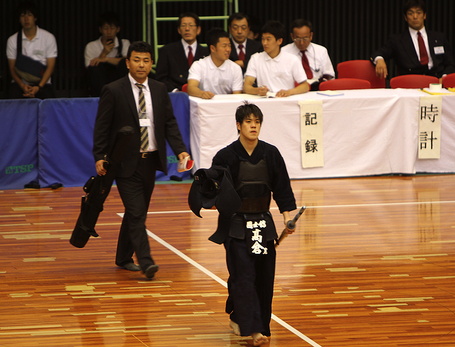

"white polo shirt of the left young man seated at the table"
[188, 55, 243, 94]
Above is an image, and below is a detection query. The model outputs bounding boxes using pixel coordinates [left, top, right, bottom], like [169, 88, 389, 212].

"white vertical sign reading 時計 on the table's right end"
[419, 96, 442, 159]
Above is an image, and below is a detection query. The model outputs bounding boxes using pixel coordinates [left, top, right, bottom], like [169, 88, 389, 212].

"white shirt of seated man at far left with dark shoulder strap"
[6, 26, 57, 84]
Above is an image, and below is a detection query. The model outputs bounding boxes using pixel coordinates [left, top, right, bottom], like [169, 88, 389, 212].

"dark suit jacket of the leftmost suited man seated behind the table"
[155, 41, 210, 92]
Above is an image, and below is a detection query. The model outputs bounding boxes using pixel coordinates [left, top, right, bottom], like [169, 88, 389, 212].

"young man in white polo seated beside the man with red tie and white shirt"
[243, 21, 310, 97]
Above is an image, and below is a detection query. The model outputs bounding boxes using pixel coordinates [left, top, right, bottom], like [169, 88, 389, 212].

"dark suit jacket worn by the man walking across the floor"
[93, 75, 188, 177]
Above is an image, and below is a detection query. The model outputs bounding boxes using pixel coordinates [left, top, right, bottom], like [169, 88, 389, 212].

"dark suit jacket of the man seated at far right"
[372, 29, 455, 77]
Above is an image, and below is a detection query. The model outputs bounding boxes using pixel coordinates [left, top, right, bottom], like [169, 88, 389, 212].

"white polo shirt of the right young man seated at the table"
[245, 51, 307, 93]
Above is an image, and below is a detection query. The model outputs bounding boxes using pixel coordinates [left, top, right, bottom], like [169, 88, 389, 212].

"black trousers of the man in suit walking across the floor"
[115, 152, 159, 272]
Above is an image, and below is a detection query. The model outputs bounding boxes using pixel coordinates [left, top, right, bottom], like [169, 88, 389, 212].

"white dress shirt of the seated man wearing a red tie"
[281, 42, 335, 80]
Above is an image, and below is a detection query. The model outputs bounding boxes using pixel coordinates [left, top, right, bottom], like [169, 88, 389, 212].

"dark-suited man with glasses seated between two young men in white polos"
[228, 12, 262, 74]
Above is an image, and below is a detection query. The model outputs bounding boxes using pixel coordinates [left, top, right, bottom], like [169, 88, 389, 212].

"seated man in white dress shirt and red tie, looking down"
[282, 19, 335, 90]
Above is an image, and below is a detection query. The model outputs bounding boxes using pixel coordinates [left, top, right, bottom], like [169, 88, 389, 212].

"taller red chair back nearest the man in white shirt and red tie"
[337, 60, 385, 88]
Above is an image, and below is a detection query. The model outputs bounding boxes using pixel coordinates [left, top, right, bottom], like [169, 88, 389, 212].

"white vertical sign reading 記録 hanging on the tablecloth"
[299, 100, 324, 169]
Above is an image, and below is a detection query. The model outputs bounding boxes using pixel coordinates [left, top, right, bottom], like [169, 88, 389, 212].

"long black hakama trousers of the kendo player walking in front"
[224, 236, 276, 336]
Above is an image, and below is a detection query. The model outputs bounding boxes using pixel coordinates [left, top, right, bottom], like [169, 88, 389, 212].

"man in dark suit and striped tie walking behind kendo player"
[93, 42, 189, 278]
